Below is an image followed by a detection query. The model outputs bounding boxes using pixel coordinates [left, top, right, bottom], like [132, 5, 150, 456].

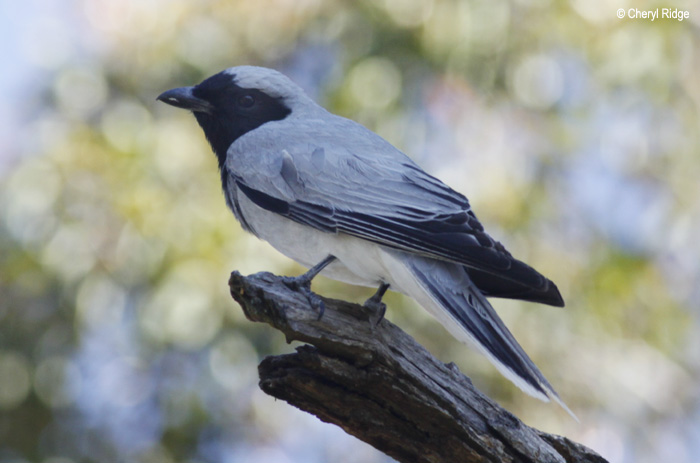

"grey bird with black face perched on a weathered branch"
[157, 65, 576, 419]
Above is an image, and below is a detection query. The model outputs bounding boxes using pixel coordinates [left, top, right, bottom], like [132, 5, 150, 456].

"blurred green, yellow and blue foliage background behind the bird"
[0, 0, 700, 463]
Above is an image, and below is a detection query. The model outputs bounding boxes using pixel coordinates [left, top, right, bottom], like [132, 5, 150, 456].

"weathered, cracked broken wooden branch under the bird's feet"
[229, 272, 605, 463]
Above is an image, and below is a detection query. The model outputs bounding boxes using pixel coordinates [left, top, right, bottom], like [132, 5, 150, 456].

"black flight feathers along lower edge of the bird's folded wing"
[236, 174, 564, 306]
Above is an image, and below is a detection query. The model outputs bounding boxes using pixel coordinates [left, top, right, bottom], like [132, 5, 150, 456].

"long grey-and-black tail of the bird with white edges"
[396, 256, 578, 421]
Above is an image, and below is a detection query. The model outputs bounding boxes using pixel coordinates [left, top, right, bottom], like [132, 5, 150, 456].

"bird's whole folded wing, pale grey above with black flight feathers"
[224, 118, 563, 305]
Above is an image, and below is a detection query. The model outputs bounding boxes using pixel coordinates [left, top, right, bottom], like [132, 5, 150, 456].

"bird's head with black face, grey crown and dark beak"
[158, 66, 313, 166]
